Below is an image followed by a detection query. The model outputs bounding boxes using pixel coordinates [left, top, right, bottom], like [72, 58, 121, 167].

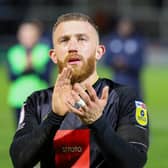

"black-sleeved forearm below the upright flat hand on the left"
[10, 113, 63, 168]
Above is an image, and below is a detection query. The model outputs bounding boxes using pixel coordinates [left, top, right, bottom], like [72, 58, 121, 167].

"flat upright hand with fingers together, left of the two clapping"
[52, 67, 72, 116]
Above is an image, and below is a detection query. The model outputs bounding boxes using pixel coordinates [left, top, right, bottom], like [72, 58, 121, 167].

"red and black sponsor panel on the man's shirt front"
[53, 129, 90, 168]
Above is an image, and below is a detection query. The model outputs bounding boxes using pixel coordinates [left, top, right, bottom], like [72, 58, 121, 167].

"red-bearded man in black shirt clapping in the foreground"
[10, 13, 149, 168]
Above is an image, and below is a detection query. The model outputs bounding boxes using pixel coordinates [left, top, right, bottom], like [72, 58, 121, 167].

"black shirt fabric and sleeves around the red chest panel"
[10, 79, 149, 168]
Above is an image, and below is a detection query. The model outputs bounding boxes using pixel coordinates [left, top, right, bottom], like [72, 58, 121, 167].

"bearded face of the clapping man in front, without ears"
[53, 21, 98, 83]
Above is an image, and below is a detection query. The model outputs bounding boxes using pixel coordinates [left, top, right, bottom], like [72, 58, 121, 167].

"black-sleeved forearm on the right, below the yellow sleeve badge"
[90, 117, 146, 168]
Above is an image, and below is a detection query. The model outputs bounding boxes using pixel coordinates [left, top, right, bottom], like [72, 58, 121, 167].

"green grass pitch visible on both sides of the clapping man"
[0, 65, 168, 168]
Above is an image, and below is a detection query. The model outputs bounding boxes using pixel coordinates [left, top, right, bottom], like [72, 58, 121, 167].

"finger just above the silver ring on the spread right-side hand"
[73, 83, 91, 105]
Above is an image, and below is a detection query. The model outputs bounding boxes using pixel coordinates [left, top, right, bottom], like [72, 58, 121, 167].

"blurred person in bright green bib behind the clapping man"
[7, 21, 51, 122]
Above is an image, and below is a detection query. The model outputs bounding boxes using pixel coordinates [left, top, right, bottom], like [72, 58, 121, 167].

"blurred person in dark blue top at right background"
[103, 18, 145, 97]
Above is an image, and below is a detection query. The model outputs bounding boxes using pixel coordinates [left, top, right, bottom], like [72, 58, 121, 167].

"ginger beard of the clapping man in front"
[57, 54, 96, 84]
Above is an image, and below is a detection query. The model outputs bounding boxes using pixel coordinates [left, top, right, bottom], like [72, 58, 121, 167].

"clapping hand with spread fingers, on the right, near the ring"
[67, 84, 109, 124]
